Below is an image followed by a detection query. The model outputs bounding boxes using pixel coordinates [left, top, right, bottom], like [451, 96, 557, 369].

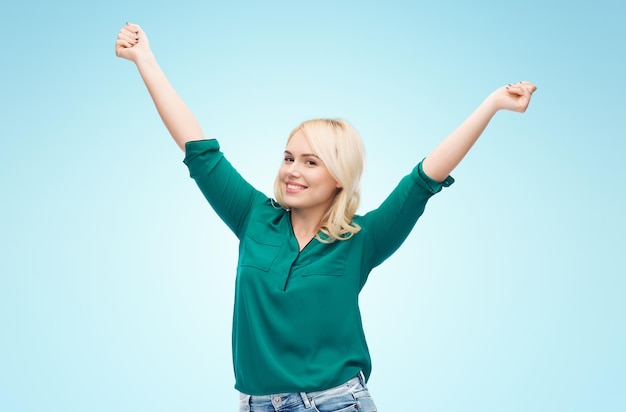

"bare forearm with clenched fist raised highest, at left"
[115, 23, 204, 151]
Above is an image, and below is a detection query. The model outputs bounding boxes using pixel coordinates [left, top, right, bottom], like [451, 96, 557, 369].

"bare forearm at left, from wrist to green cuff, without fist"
[136, 54, 204, 150]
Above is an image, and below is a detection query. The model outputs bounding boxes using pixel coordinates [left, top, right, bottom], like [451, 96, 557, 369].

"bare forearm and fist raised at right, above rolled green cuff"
[422, 81, 537, 182]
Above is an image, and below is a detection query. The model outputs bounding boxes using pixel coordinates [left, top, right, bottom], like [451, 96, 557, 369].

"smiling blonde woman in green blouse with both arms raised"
[116, 23, 536, 412]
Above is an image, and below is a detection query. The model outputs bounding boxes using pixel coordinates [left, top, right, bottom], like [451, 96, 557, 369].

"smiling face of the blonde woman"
[278, 130, 340, 218]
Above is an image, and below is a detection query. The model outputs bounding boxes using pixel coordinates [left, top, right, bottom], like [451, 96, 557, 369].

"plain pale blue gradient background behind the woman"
[0, 0, 626, 412]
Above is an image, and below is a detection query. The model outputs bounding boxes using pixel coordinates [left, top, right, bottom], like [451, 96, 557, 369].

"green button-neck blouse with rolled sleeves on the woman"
[184, 140, 454, 395]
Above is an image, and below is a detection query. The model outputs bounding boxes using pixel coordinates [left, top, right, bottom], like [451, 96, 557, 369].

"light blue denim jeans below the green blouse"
[239, 374, 376, 412]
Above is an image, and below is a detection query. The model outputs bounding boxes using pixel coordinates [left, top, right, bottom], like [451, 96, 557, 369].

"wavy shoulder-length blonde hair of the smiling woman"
[274, 119, 365, 243]
